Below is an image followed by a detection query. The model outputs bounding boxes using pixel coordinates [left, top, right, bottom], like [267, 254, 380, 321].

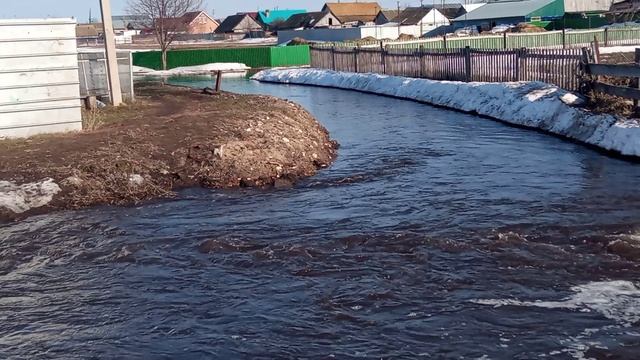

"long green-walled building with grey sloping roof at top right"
[454, 0, 564, 30]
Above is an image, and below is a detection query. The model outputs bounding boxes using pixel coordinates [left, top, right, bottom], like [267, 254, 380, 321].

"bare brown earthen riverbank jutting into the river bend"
[0, 86, 337, 220]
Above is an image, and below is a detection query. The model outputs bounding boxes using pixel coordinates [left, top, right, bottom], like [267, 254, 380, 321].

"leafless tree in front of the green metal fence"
[129, 0, 202, 70]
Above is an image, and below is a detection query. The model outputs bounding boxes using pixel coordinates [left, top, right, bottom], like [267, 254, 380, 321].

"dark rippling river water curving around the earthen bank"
[0, 80, 640, 359]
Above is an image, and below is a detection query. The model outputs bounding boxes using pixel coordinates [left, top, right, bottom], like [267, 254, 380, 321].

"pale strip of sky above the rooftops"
[0, 0, 450, 22]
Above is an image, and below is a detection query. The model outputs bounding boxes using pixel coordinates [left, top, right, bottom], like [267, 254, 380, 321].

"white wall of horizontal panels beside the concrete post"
[0, 19, 82, 137]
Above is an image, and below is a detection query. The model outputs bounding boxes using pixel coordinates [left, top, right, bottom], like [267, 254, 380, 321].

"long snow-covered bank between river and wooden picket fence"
[253, 69, 640, 156]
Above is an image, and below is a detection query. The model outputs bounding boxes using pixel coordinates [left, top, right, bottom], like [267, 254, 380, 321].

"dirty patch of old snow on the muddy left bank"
[0, 179, 61, 214]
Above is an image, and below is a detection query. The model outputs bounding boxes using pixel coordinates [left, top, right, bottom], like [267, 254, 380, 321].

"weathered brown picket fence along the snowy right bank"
[311, 46, 582, 91]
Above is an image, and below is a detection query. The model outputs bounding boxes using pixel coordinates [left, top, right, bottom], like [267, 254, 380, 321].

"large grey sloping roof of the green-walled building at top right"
[454, 0, 555, 21]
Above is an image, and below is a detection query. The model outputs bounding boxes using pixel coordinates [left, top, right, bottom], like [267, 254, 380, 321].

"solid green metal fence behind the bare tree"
[133, 45, 310, 70]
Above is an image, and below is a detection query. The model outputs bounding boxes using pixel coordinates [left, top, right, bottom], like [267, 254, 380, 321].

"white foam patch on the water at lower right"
[473, 280, 640, 326]
